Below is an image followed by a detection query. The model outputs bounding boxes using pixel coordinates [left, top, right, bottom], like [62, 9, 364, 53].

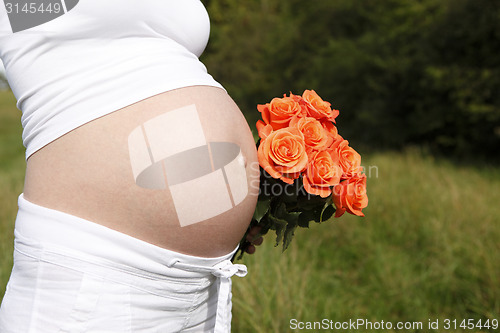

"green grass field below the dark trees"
[0, 89, 500, 333]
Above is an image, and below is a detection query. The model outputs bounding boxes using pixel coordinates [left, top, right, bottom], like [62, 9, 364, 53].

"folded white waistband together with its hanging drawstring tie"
[15, 194, 247, 333]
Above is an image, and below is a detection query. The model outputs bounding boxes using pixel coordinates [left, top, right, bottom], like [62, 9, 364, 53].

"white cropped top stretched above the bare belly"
[0, 0, 222, 158]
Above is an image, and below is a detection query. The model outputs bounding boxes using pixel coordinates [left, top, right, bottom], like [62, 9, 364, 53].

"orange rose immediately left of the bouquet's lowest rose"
[302, 150, 342, 198]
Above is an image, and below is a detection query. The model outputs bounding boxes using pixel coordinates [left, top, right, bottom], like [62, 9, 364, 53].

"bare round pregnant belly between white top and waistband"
[24, 86, 259, 257]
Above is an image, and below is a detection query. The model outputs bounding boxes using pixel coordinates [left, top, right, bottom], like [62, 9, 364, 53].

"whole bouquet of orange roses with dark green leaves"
[234, 90, 368, 258]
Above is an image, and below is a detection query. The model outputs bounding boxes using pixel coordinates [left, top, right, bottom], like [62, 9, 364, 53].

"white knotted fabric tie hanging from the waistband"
[169, 260, 247, 333]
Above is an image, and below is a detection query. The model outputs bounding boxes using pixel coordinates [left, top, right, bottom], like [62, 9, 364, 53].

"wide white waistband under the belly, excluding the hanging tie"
[15, 194, 241, 277]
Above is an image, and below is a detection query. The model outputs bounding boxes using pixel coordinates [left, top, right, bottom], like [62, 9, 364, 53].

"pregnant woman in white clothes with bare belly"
[0, 0, 259, 333]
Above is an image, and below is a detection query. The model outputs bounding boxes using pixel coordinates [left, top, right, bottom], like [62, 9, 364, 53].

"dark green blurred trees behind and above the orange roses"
[203, 0, 500, 161]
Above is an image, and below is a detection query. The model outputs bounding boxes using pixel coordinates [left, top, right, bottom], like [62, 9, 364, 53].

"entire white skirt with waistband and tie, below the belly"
[0, 194, 246, 333]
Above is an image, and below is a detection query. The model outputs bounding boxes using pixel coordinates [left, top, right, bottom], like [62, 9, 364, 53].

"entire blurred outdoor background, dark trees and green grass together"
[0, 0, 500, 333]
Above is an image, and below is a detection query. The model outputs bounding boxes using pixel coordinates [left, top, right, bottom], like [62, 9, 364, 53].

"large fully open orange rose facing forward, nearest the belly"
[257, 127, 307, 184]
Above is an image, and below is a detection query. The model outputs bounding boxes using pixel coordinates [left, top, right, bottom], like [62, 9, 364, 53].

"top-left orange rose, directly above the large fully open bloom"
[257, 94, 304, 130]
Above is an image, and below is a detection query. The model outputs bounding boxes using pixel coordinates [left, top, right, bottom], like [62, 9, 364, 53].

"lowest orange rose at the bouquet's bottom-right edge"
[333, 174, 368, 217]
